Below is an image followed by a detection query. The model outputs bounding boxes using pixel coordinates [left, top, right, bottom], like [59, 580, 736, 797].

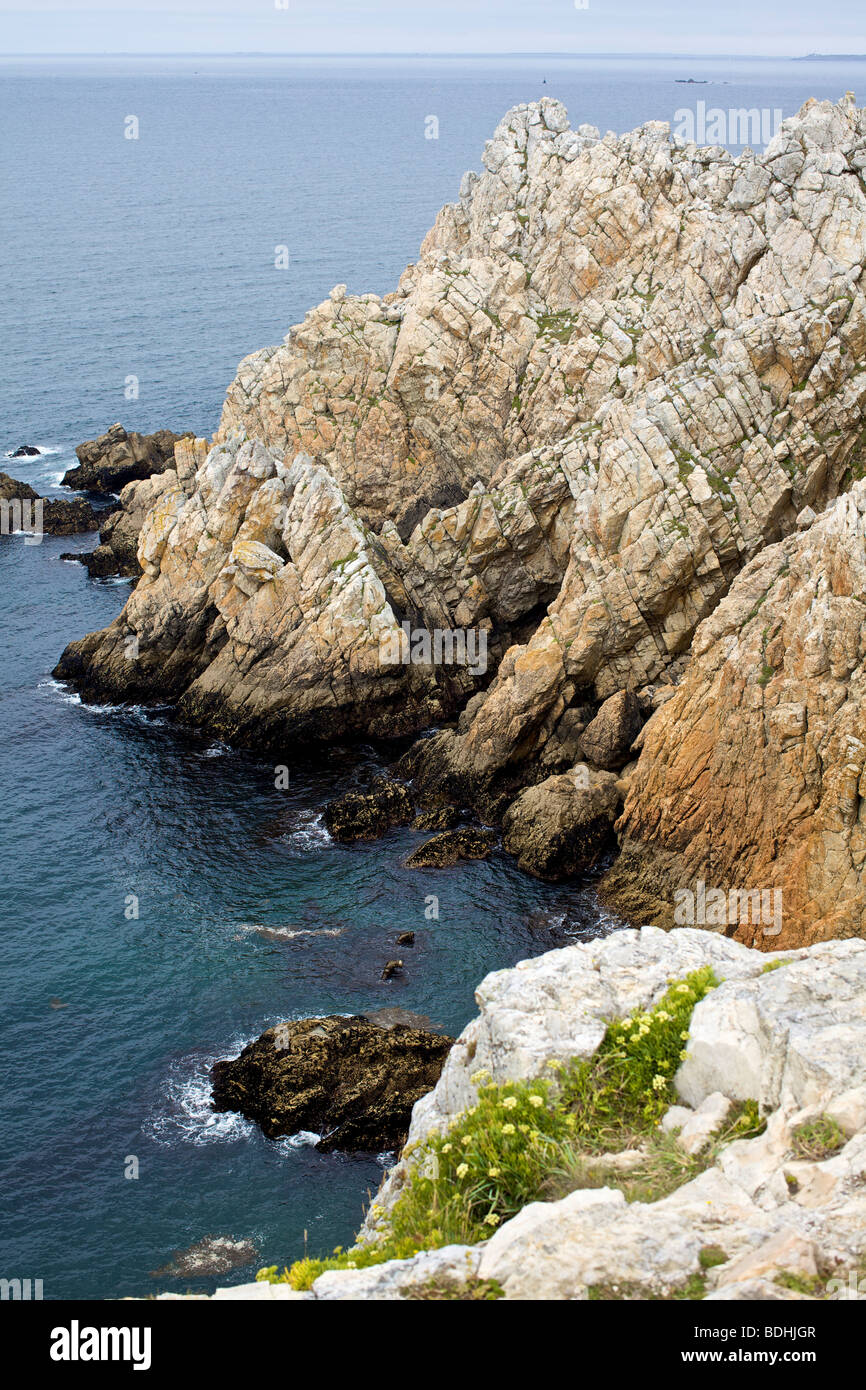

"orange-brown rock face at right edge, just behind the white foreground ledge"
[606, 482, 866, 949]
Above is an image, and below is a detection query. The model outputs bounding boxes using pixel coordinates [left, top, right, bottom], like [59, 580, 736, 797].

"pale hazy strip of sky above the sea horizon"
[0, 0, 866, 56]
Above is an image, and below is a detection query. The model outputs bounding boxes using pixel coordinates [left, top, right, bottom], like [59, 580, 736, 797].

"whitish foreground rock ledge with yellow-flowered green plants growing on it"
[152, 927, 866, 1301]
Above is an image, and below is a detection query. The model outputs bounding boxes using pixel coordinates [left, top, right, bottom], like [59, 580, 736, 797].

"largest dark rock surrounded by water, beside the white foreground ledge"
[211, 1016, 453, 1152]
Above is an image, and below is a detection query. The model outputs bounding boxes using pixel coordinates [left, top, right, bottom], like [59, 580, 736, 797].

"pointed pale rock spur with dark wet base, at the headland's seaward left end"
[57, 438, 494, 746]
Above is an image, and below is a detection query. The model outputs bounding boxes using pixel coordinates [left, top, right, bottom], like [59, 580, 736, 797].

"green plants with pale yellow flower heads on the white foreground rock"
[257, 967, 745, 1297]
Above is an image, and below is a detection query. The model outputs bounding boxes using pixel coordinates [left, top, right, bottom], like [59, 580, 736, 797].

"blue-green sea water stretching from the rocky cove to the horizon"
[0, 58, 866, 1298]
